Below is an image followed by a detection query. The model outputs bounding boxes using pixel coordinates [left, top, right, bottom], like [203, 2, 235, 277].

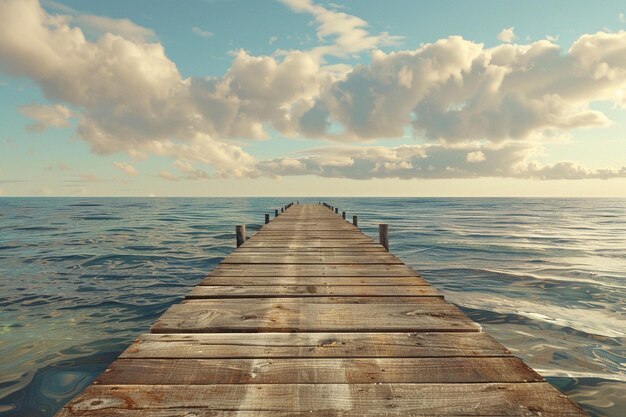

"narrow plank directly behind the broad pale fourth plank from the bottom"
[186, 285, 443, 299]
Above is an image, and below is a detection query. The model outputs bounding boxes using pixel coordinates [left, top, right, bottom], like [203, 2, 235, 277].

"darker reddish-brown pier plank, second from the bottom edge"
[96, 357, 543, 385]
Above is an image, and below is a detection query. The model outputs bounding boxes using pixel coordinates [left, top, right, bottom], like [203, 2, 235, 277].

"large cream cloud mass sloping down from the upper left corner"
[0, 0, 258, 175]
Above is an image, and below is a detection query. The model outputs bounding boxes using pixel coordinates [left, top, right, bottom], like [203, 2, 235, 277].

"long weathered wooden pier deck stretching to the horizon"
[57, 205, 586, 417]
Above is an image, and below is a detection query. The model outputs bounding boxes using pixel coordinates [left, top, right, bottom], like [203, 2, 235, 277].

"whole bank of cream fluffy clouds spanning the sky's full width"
[0, 0, 626, 180]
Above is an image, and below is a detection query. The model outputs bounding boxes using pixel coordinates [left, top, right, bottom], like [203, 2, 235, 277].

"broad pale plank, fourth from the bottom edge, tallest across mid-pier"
[151, 297, 480, 333]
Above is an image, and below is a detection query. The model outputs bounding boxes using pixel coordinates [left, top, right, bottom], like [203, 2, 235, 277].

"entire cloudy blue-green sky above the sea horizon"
[0, 0, 626, 197]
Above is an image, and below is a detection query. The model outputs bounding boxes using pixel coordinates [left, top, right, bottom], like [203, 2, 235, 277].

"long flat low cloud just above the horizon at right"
[258, 142, 626, 180]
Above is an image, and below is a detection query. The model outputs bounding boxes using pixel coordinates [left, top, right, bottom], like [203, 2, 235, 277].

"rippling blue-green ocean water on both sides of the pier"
[0, 198, 626, 417]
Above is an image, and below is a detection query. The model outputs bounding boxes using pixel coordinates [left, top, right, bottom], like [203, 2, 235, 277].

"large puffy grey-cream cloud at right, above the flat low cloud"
[299, 32, 626, 143]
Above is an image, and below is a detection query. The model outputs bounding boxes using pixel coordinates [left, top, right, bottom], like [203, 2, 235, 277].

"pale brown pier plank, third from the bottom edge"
[120, 332, 511, 359]
